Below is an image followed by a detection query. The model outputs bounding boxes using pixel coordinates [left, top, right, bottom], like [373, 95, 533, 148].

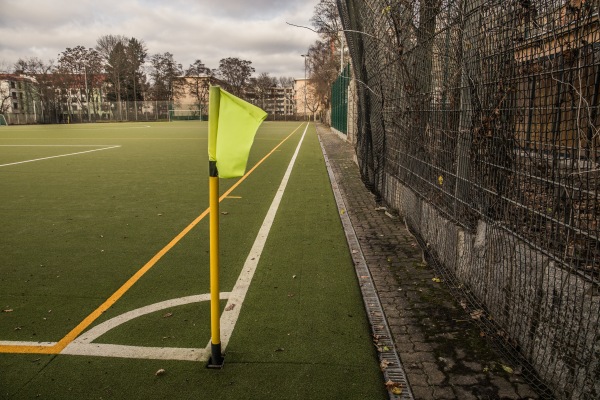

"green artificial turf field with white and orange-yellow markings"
[0, 121, 387, 399]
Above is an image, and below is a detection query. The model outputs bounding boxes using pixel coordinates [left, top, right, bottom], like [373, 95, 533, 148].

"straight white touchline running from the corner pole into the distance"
[216, 124, 309, 350]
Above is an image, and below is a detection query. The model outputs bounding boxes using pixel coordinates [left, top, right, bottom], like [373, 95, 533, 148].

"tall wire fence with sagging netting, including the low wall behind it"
[338, 0, 600, 399]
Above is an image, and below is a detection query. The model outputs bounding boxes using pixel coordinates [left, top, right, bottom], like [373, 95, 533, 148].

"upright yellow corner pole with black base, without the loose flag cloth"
[207, 86, 224, 369]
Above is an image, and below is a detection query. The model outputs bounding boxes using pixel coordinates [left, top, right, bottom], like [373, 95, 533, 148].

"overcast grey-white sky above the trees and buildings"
[0, 0, 319, 78]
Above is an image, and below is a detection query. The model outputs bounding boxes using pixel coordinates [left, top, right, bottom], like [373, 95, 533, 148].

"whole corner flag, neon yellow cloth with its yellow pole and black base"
[207, 86, 267, 368]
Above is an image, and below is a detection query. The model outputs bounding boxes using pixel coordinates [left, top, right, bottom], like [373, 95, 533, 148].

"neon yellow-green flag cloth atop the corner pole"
[208, 86, 267, 178]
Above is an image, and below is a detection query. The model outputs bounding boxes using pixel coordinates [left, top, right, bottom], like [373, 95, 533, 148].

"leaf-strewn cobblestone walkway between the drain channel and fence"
[317, 125, 538, 400]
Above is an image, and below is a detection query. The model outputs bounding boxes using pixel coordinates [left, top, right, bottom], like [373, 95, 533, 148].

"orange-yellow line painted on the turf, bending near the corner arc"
[0, 124, 302, 354]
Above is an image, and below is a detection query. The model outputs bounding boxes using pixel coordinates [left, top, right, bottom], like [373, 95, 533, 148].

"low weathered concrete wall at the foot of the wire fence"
[383, 175, 600, 399]
